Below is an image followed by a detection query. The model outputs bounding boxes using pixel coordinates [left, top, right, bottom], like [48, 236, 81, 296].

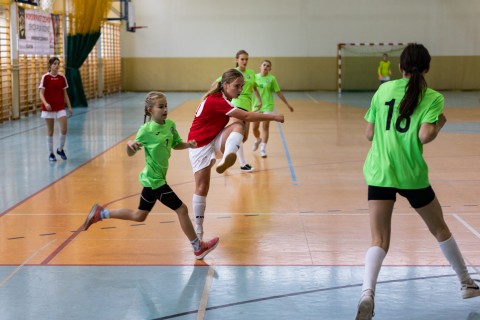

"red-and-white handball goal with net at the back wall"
[337, 42, 408, 95]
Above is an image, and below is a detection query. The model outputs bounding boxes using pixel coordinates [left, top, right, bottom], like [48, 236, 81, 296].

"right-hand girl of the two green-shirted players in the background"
[252, 60, 293, 158]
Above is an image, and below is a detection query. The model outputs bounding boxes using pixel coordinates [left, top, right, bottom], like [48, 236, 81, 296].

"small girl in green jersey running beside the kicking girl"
[84, 92, 219, 259]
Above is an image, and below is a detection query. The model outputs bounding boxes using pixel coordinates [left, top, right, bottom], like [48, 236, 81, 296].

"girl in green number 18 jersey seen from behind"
[355, 44, 480, 320]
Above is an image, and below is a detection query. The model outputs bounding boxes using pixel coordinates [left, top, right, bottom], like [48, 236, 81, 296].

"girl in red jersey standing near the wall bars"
[39, 57, 73, 161]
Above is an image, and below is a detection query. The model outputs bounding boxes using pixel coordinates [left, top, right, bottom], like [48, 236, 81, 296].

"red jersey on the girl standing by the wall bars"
[39, 72, 68, 112]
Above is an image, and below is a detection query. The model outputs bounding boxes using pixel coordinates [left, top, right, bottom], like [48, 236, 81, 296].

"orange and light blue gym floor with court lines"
[0, 92, 480, 320]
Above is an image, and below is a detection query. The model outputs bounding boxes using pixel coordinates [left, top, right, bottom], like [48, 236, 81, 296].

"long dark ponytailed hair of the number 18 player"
[399, 43, 431, 119]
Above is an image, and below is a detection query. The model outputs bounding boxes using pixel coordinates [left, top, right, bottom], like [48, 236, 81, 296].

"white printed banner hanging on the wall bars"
[18, 7, 55, 55]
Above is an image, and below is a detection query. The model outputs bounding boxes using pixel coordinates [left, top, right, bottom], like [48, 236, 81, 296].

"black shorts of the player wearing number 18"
[368, 186, 435, 209]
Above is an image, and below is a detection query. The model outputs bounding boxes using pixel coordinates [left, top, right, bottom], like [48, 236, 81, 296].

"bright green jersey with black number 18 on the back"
[363, 78, 444, 189]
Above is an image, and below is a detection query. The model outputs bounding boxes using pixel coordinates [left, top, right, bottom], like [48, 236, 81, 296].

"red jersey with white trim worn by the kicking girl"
[188, 92, 235, 147]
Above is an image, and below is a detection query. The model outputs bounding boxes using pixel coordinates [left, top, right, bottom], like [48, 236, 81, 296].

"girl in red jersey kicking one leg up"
[188, 69, 284, 239]
